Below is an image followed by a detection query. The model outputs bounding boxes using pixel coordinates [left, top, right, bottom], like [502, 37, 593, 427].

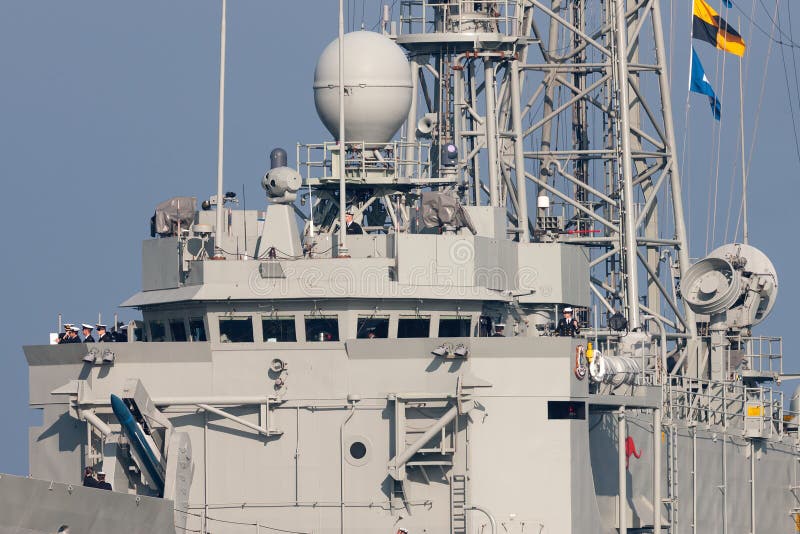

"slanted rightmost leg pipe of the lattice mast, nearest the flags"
[652, 0, 697, 338]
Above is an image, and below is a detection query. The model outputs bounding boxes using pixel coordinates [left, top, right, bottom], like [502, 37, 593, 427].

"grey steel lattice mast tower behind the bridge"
[397, 0, 696, 352]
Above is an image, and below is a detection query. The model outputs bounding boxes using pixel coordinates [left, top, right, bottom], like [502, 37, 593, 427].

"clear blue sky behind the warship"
[0, 0, 800, 474]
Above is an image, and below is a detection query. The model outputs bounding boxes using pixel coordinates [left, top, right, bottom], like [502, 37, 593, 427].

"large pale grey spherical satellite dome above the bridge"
[314, 31, 413, 144]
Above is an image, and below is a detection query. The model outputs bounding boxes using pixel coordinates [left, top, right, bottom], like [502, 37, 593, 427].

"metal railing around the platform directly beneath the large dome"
[297, 141, 431, 182]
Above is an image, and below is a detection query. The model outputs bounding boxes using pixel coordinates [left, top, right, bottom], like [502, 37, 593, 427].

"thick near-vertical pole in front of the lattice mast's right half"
[614, 0, 640, 330]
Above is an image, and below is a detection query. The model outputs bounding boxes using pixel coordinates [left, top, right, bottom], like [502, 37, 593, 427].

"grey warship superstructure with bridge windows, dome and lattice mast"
[0, 0, 800, 534]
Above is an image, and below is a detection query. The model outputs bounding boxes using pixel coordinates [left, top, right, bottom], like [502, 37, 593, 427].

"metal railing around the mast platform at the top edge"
[400, 0, 523, 36]
